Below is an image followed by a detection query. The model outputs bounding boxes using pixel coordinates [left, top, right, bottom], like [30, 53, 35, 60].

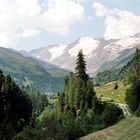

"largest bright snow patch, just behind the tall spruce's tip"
[68, 37, 100, 57]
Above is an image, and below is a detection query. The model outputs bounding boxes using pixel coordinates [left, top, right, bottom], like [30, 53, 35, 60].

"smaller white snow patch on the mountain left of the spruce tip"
[49, 45, 67, 60]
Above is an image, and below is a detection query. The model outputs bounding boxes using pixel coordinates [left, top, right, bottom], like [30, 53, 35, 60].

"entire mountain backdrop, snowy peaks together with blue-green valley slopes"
[0, 33, 140, 92]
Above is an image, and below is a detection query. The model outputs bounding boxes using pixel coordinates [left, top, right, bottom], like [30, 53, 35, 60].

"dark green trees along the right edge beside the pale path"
[126, 49, 140, 115]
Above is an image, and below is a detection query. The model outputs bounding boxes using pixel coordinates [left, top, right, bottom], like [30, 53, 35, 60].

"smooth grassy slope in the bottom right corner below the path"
[80, 117, 140, 140]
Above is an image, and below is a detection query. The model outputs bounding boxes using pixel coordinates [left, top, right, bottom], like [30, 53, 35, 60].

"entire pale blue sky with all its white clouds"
[0, 0, 140, 50]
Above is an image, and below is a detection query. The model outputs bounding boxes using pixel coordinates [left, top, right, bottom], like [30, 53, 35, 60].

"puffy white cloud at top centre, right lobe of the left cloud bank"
[42, 0, 84, 35]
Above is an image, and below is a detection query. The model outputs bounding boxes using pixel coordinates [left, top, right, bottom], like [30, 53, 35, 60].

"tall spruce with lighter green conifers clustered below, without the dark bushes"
[59, 50, 96, 116]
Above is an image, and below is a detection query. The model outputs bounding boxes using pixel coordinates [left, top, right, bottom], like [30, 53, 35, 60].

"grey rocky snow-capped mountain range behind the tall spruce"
[29, 33, 140, 73]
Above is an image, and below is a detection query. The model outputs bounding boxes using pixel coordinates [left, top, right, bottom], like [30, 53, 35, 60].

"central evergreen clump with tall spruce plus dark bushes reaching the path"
[53, 51, 122, 140]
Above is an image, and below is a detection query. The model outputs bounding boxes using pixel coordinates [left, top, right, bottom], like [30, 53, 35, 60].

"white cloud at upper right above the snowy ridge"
[93, 2, 140, 39]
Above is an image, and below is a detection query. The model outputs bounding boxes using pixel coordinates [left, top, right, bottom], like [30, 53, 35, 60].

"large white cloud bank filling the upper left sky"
[0, 0, 85, 47]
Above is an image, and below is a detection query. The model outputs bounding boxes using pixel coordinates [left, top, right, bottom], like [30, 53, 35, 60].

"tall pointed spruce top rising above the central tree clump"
[75, 50, 88, 81]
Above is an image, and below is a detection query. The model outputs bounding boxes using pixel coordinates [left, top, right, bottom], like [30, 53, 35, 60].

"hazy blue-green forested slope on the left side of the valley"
[0, 48, 68, 92]
